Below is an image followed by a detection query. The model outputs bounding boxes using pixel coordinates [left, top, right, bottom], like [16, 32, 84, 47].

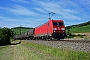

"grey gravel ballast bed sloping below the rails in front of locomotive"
[25, 39, 90, 52]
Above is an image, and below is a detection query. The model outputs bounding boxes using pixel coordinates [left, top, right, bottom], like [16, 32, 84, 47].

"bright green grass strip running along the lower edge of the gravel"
[23, 42, 90, 60]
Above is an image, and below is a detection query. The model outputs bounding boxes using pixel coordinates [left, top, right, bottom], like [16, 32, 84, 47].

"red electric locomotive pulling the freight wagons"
[34, 20, 66, 39]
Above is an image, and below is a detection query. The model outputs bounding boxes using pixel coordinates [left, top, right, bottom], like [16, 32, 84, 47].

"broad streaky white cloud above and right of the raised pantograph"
[33, 0, 81, 20]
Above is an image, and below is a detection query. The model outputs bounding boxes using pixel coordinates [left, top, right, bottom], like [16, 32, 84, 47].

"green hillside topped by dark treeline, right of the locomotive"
[66, 21, 90, 33]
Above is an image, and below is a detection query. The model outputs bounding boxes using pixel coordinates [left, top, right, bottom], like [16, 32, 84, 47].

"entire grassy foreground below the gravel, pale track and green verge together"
[0, 41, 90, 60]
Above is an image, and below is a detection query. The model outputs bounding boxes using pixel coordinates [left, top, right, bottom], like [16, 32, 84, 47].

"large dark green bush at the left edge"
[0, 27, 14, 45]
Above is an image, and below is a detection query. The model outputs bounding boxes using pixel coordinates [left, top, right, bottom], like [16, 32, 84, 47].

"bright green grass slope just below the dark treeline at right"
[70, 25, 90, 33]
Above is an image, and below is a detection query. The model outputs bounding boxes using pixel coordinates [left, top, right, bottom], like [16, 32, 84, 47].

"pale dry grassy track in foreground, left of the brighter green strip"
[0, 44, 60, 60]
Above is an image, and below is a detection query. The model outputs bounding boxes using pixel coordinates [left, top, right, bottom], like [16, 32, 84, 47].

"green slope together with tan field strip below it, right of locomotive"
[66, 24, 90, 40]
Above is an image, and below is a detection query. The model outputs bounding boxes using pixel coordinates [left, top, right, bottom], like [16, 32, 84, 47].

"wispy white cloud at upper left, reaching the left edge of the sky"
[0, 4, 38, 16]
